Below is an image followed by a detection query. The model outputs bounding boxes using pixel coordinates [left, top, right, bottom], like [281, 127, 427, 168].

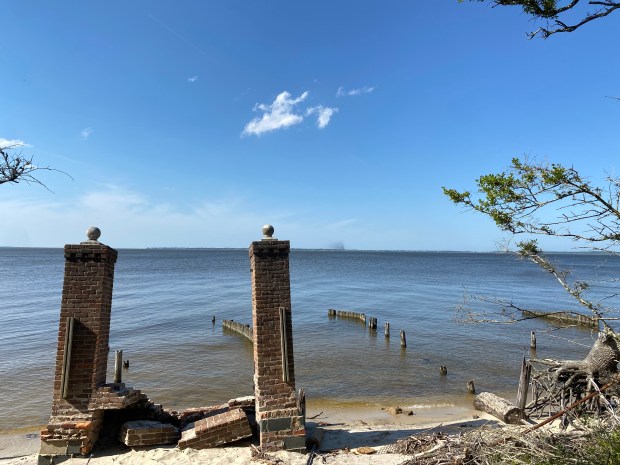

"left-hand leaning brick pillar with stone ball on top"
[41, 228, 117, 455]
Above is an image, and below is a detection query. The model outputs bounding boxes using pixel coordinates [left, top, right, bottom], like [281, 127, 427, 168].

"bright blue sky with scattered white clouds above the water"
[0, 0, 620, 251]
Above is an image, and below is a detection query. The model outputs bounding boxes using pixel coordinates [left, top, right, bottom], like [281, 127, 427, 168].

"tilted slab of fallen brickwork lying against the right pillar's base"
[178, 408, 252, 449]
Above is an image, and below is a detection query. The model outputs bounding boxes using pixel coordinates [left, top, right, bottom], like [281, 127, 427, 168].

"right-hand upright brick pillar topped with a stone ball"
[249, 225, 306, 451]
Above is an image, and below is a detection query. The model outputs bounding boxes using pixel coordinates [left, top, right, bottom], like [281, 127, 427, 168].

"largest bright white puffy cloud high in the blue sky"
[241, 91, 309, 136]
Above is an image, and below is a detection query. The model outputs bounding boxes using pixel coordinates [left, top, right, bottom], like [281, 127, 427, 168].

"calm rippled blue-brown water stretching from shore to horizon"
[0, 248, 620, 430]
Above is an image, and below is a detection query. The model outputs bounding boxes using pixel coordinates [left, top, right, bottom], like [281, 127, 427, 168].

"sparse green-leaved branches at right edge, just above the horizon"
[443, 158, 620, 246]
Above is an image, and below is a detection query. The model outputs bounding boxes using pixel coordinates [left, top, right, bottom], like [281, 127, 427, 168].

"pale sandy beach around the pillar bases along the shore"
[0, 406, 498, 465]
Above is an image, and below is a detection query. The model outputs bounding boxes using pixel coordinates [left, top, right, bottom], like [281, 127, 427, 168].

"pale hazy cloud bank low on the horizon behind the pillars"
[0, 186, 289, 248]
